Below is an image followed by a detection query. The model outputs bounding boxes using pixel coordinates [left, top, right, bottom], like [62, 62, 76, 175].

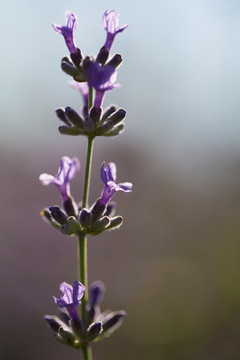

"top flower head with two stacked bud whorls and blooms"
[53, 10, 128, 138]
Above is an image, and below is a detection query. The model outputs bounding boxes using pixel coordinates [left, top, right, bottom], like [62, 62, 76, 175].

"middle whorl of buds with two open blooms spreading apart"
[39, 156, 132, 235]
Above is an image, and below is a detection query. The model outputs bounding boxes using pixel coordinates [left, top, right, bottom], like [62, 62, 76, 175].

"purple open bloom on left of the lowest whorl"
[53, 281, 85, 319]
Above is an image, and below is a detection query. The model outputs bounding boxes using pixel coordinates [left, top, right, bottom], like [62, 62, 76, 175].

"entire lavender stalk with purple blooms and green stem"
[39, 10, 132, 360]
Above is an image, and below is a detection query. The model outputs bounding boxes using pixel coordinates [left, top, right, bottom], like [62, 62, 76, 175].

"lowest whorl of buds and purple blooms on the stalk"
[44, 281, 126, 349]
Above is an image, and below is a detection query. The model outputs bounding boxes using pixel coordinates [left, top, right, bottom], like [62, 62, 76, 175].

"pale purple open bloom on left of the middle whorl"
[39, 156, 80, 201]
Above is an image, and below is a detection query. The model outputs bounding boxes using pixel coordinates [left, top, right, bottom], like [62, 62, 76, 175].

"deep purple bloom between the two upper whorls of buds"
[87, 62, 119, 107]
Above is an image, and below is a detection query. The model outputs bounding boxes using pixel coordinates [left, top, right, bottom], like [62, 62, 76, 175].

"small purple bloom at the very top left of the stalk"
[52, 10, 78, 54]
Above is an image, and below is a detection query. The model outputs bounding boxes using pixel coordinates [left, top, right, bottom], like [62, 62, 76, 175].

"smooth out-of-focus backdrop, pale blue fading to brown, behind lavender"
[0, 0, 240, 360]
